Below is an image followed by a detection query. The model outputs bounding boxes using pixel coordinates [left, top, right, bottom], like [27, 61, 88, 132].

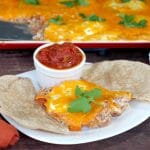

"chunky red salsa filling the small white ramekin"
[37, 43, 83, 69]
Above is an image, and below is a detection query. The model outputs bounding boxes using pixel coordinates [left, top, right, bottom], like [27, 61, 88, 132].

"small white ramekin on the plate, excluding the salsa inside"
[33, 44, 86, 88]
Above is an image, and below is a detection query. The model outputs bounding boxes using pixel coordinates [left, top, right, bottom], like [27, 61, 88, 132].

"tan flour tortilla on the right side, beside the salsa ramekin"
[82, 60, 150, 101]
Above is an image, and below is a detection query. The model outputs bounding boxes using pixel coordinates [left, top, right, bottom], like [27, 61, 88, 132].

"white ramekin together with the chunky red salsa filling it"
[33, 43, 86, 88]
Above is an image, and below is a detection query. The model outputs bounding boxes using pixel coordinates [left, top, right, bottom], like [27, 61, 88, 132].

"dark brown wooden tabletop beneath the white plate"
[0, 49, 150, 150]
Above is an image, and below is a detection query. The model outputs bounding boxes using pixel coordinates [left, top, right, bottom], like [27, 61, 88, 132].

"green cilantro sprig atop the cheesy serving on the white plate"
[68, 86, 102, 113]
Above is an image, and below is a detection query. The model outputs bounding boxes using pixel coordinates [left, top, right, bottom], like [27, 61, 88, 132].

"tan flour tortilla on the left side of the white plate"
[0, 75, 68, 134]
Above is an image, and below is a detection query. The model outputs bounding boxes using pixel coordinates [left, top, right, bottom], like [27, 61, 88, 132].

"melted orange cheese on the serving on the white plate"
[36, 80, 131, 131]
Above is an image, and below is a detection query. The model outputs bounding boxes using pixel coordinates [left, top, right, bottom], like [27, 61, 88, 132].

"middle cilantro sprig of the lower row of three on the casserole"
[79, 13, 105, 22]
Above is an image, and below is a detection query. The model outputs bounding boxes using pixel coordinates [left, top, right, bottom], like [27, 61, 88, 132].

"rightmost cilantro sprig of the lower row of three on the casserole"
[119, 14, 147, 28]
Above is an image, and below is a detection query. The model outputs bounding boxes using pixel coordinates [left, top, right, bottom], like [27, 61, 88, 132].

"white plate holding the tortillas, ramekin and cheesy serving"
[3, 71, 150, 145]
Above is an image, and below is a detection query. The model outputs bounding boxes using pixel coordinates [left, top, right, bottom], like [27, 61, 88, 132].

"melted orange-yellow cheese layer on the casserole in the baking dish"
[0, 0, 150, 41]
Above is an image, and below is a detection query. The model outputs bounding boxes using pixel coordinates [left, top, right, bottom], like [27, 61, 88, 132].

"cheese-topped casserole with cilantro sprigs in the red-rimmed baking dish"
[0, 0, 150, 41]
